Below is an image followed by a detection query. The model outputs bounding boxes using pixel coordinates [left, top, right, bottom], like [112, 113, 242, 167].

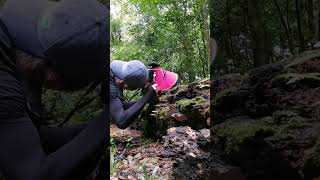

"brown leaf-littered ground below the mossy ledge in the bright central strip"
[110, 125, 210, 180]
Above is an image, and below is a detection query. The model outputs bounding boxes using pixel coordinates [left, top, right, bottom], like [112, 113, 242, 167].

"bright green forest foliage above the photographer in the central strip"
[111, 0, 209, 83]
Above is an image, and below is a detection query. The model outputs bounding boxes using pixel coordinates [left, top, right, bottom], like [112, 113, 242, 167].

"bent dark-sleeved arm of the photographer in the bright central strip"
[110, 86, 155, 129]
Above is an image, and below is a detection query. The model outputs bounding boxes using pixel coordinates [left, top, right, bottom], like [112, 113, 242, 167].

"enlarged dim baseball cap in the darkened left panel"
[1, 0, 110, 85]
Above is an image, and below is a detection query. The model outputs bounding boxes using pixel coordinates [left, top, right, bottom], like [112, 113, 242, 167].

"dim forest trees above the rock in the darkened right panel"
[210, 0, 320, 76]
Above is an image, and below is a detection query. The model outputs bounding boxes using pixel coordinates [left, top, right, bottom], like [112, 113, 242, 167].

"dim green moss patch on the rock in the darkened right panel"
[213, 111, 304, 154]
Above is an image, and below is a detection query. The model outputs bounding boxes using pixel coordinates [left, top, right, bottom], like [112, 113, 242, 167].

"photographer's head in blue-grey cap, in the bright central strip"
[110, 60, 148, 90]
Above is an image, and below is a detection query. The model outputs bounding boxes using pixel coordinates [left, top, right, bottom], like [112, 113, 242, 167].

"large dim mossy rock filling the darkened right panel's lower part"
[210, 50, 320, 180]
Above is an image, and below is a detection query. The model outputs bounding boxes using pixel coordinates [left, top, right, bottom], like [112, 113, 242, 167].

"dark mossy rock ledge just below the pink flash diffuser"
[132, 79, 210, 138]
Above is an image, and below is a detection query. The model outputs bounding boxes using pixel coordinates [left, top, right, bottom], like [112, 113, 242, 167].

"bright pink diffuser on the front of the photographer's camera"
[153, 67, 178, 90]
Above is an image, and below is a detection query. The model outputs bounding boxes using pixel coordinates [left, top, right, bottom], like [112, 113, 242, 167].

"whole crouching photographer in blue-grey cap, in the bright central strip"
[109, 60, 158, 129]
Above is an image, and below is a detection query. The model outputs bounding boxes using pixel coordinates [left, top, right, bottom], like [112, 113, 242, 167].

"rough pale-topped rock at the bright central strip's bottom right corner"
[161, 127, 211, 179]
